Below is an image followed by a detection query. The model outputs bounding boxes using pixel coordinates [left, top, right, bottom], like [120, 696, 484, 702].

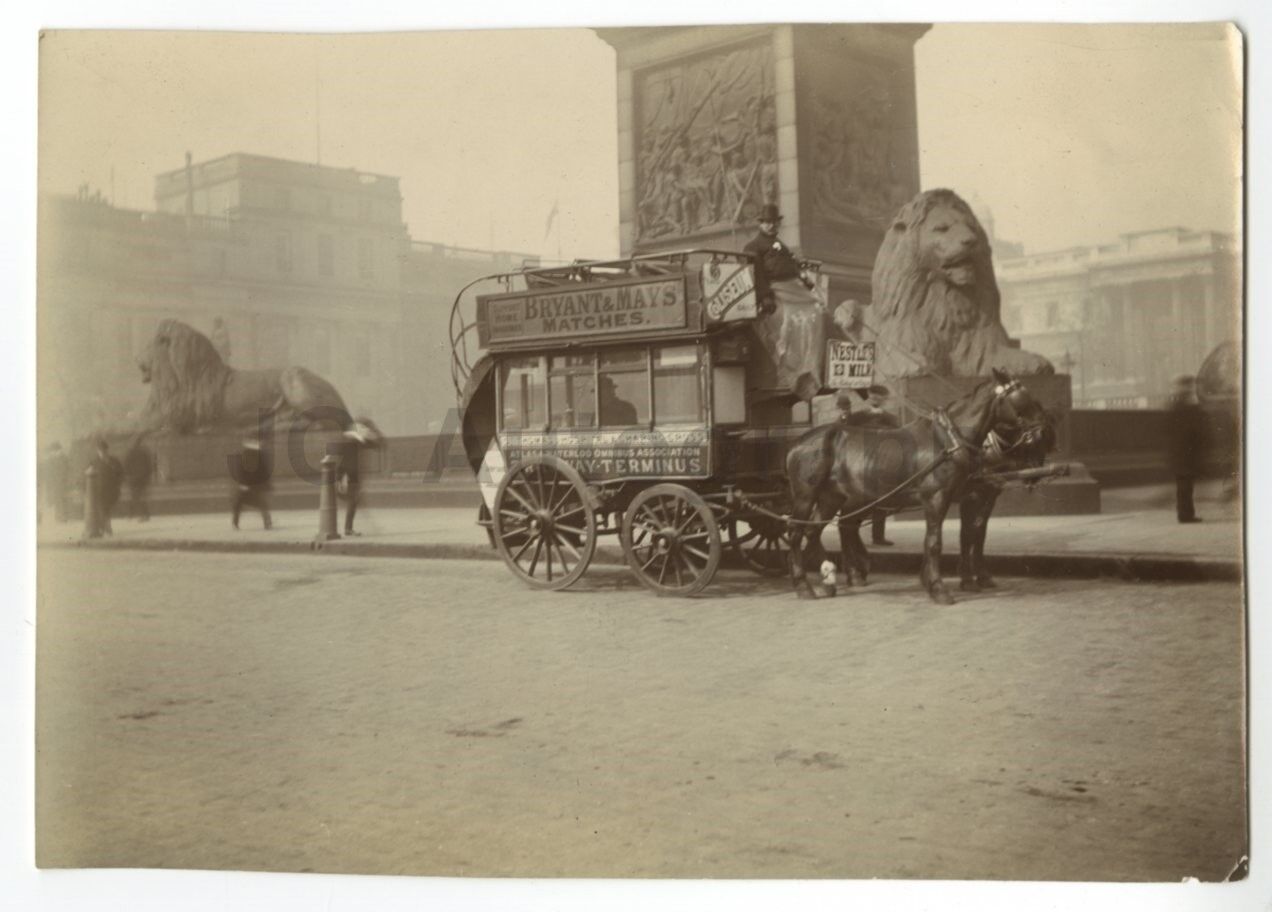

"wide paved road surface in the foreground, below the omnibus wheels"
[37, 549, 1244, 880]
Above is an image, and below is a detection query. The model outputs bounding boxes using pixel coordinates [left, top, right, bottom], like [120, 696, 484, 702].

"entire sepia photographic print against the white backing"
[19, 3, 1258, 908]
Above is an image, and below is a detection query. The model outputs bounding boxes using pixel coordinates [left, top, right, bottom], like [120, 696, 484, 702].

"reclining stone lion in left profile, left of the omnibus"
[137, 319, 350, 434]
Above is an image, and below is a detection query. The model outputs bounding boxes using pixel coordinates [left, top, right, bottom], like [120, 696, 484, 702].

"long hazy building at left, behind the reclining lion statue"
[38, 153, 534, 438]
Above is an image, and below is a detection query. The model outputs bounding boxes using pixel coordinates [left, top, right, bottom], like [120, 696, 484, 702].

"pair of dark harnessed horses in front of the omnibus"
[786, 370, 1054, 604]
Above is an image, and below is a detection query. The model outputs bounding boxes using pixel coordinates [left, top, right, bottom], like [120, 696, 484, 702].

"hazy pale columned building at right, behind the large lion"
[995, 228, 1241, 408]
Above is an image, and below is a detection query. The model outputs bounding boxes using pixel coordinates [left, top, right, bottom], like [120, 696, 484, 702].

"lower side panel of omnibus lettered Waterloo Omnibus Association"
[502, 427, 711, 481]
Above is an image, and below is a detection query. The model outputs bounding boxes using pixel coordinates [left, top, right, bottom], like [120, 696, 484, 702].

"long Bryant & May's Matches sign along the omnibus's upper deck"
[481, 279, 686, 345]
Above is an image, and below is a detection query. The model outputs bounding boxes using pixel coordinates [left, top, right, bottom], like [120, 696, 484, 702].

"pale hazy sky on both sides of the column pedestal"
[41, 25, 1240, 257]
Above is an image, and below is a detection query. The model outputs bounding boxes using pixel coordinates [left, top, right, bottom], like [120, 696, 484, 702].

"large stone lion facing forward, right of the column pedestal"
[870, 190, 1054, 378]
